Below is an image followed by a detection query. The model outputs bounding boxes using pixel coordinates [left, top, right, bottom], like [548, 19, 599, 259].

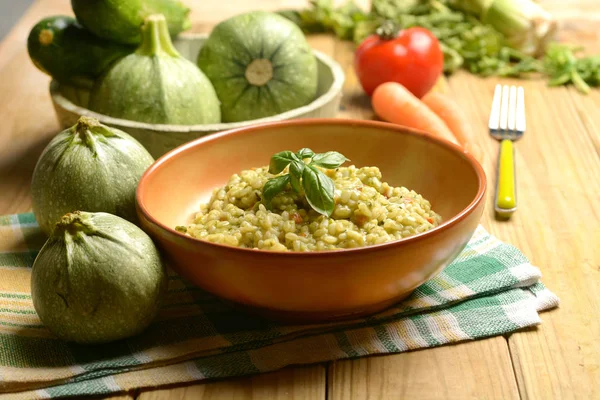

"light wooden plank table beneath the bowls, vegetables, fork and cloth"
[0, 0, 600, 400]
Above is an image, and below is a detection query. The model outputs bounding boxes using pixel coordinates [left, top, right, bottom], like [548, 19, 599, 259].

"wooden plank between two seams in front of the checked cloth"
[327, 337, 519, 400]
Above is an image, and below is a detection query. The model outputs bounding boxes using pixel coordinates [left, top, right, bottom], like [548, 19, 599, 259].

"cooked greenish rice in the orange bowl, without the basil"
[187, 166, 441, 251]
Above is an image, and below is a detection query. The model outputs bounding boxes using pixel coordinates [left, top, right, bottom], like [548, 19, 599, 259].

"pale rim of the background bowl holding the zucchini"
[50, 33, 346, 133]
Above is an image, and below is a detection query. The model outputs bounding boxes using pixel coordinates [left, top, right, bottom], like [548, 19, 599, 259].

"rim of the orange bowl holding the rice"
[135, 118, 487, 257]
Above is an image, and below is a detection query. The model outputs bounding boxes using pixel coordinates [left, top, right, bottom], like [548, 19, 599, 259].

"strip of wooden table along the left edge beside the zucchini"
[0, 1, 68, 214]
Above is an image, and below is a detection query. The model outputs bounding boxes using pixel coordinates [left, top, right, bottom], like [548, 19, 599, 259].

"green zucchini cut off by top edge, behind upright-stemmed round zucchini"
[71, 0, 191, 44]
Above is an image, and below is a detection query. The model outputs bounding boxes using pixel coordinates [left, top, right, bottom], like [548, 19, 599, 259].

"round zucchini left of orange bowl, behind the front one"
[31, 117, 154, 234]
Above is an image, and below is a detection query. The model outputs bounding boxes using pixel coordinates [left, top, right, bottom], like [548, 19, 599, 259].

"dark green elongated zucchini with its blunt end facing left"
[27, 16, 135, 88]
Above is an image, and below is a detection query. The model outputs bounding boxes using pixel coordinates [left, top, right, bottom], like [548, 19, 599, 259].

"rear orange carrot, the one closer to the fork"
[421, 92, 475, 146]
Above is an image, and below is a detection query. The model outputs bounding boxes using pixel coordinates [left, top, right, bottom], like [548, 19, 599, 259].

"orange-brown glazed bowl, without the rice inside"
[137, 119, 486, 322]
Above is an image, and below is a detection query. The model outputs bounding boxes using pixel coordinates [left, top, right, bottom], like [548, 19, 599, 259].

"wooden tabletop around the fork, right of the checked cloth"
[450, 71, 600, 399]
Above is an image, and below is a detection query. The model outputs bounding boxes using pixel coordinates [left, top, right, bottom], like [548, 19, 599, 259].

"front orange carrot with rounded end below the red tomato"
[371, 82, 458, 144]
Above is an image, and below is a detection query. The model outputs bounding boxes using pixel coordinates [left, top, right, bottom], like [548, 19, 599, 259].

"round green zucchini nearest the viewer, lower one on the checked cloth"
[31, 211, 168, 344]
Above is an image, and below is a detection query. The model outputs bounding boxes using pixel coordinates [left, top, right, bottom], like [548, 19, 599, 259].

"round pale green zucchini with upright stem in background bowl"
[89, 14, 221, 125]
